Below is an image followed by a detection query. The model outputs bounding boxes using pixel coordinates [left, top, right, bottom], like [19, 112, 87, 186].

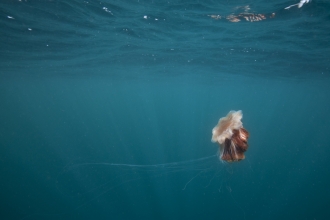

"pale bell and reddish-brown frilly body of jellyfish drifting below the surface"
[212, 111, 249, 162]
